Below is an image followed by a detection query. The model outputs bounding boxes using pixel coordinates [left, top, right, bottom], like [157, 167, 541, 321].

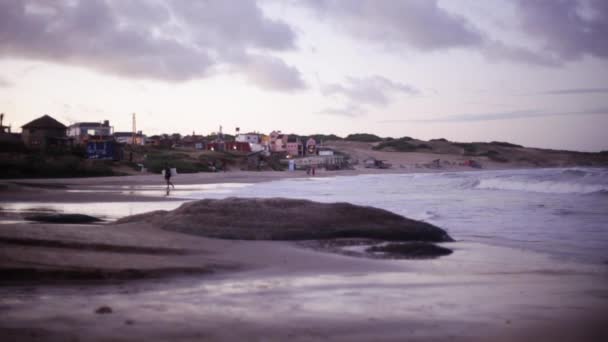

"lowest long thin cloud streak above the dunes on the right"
[380, 106, 608, 123]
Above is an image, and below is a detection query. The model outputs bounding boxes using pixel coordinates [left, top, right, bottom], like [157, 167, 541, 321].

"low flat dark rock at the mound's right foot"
[366, 242, 452, 259]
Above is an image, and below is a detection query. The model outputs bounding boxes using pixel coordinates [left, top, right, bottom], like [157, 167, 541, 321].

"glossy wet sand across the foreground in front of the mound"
[0, 220, 608, 341]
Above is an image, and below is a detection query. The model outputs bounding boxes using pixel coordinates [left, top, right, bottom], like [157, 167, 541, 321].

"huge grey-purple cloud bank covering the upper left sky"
[0, 0, 301, 90]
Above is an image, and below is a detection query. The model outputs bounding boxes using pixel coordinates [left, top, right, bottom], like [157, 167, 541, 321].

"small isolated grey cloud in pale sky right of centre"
[321, 76, 419, 106]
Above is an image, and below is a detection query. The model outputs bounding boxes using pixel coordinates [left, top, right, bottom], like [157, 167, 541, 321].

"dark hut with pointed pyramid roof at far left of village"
[21, 115, 72, 150]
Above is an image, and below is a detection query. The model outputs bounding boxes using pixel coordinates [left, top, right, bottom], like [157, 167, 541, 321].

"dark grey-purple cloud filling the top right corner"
[517, 0, 608, 61]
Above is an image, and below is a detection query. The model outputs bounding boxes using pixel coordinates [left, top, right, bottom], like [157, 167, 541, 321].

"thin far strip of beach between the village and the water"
[0, 165, 602, 204]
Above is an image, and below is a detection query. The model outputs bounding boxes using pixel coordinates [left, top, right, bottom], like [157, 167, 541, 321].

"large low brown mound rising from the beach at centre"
[116, 198, 453, 242]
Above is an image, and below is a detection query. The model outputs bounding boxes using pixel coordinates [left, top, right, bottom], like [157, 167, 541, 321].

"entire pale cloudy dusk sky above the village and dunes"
[0, 0, 608, 151]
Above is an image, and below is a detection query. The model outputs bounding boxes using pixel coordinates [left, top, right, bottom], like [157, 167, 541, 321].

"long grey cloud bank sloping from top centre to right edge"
[297, 0, 608, 67]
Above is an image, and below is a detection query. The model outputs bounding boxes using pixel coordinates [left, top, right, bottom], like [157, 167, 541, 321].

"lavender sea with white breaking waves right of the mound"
[188, 168, 608, 263]
